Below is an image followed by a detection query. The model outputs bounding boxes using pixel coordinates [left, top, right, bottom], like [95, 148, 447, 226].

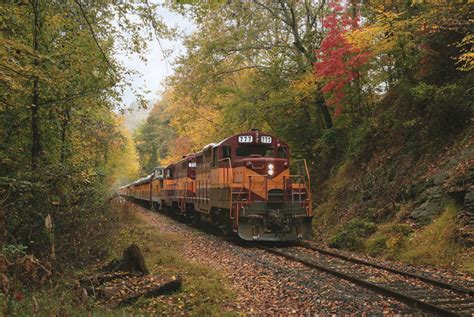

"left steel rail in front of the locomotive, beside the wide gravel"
[257, 245, 461, 316]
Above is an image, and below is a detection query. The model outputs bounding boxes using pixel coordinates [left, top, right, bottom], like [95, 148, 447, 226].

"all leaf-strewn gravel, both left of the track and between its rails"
[129, 200, 471, 315]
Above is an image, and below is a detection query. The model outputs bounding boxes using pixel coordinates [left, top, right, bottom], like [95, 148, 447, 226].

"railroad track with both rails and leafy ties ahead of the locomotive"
[258, 243, 474, 316]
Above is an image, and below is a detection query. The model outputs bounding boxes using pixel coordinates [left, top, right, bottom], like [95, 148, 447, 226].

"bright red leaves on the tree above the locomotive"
[314, 1, 369, 116]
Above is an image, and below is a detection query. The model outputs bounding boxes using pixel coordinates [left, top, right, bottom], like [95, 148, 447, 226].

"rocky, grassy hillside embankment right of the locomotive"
[314, 116, 474, 273]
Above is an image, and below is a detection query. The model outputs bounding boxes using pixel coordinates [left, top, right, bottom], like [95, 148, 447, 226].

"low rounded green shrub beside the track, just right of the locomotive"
[329, 219, 377, 251]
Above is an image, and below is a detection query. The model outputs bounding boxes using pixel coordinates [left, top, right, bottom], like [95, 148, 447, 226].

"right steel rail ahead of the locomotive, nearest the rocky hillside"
[295, 242, 474, 296]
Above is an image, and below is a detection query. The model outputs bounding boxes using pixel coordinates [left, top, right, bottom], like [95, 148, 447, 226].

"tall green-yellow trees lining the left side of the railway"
[0, 0, 171, 262]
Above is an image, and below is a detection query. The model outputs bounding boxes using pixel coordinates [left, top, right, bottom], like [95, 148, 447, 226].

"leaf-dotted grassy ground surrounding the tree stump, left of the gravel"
[6, 201, 234, 316]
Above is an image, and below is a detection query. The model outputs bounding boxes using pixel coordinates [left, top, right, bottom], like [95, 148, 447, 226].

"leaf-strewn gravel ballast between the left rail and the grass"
[133, 208, 421, 315]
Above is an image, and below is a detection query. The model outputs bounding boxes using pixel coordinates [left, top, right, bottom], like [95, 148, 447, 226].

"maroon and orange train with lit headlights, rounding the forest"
[119, 129, 313, 241]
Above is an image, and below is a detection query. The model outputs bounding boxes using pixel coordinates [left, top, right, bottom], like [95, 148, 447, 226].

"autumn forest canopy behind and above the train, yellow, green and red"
[136, 1, 474, 175]
